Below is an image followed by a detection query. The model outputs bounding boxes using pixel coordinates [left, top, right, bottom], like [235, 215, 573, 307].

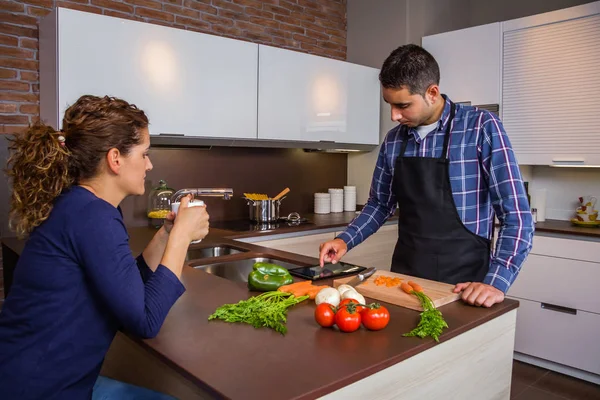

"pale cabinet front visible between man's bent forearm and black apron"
[336, 224, 398, 271]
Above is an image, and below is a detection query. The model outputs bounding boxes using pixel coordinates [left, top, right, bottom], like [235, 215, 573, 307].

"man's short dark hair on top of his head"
[379, 44, 440, 96]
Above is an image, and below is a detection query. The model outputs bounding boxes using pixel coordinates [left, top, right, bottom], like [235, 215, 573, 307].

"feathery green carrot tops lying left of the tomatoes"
[208, 292, 308, 335]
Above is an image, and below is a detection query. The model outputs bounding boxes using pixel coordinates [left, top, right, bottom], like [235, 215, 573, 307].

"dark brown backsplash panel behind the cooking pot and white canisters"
[121, 147, 348, 226]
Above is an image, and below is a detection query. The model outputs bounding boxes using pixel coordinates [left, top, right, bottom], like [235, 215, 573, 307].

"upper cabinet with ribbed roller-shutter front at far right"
[502, 2, 600, 166]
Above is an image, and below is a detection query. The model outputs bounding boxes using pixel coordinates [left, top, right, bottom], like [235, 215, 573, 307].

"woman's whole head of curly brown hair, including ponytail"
[6, 95, 148, 237]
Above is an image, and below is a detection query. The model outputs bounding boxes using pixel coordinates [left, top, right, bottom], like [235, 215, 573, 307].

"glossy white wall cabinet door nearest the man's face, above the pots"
[258, 45, 381, 144]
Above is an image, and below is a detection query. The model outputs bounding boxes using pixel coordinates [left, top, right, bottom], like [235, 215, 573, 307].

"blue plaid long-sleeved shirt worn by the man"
[338, 96, 534, 292]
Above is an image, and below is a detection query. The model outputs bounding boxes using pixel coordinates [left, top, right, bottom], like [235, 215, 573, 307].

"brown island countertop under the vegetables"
[3, 228, 518, 400]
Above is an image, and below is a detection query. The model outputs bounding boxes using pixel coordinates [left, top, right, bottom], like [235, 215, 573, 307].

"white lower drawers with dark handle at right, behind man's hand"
[507, 235, 600, 375]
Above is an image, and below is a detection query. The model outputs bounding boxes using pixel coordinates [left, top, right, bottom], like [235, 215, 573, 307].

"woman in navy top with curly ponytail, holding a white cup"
[0, 96, 208, 400]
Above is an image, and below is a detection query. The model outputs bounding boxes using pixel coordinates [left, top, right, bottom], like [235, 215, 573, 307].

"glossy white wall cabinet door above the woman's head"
[41, 8, 258, 139]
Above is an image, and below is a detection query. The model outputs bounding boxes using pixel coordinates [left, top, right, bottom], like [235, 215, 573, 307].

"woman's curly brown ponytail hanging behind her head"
[6, 122, 73, 238]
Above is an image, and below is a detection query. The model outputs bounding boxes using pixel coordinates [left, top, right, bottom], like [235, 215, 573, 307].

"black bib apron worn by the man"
[392, 103, 490, 284]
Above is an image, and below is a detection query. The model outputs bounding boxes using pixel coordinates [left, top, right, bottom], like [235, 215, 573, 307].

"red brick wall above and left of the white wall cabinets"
[0, 0, 346, 133]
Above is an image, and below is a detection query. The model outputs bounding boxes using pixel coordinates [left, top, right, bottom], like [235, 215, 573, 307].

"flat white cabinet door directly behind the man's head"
[422, 22, 501, 105]
